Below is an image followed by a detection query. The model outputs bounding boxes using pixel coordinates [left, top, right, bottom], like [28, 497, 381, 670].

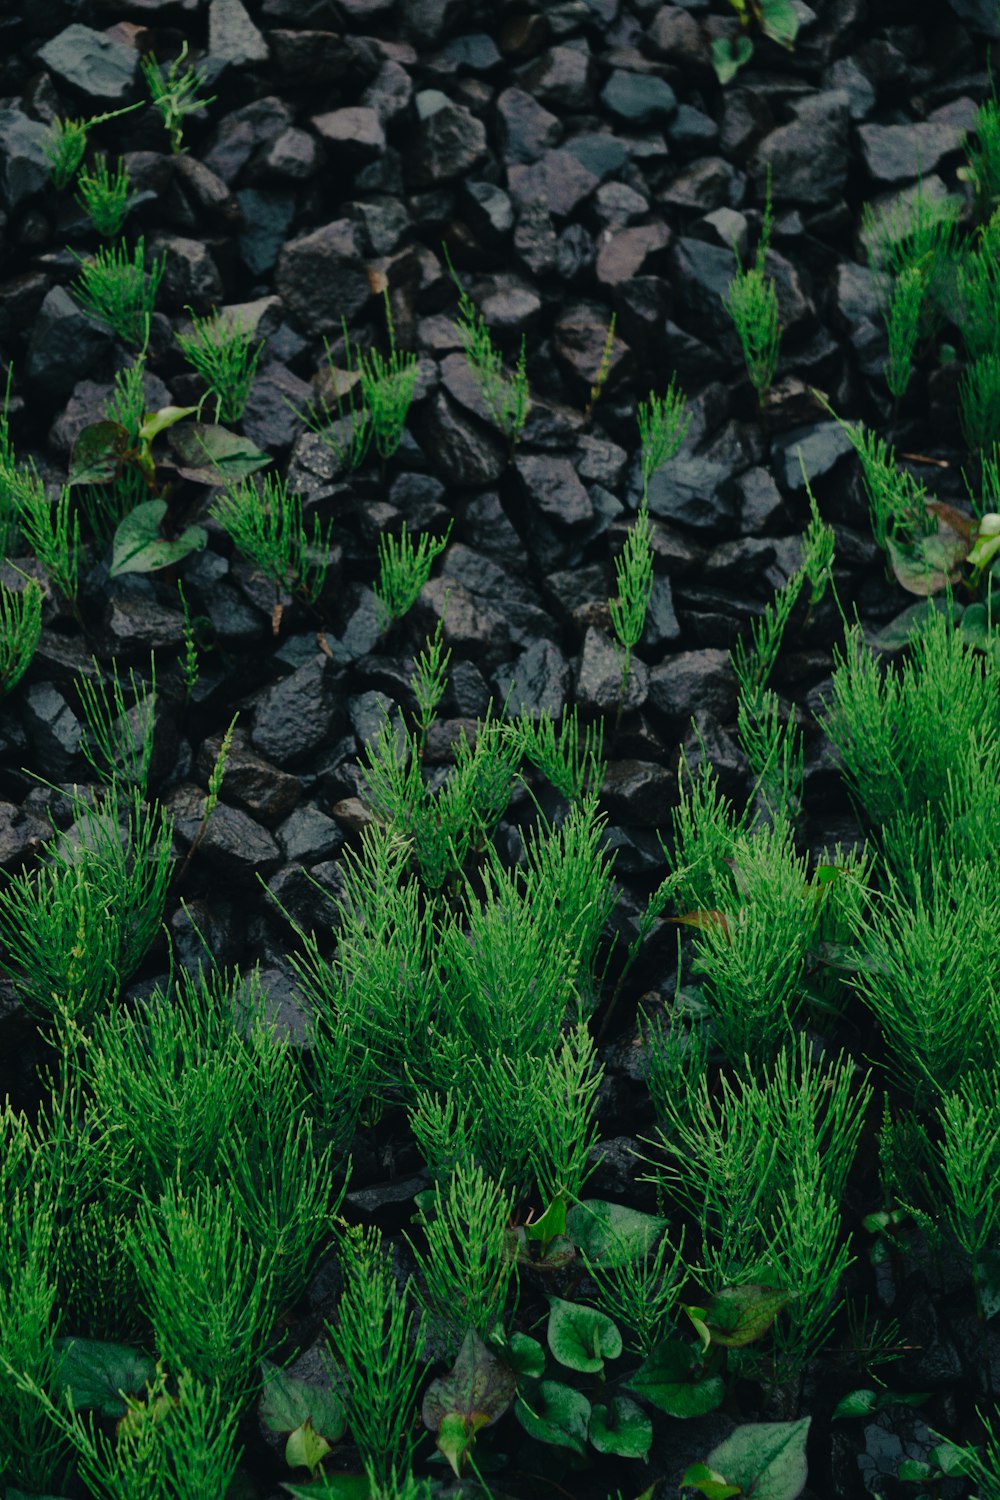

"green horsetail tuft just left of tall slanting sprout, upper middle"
[286, 293, 420, 470]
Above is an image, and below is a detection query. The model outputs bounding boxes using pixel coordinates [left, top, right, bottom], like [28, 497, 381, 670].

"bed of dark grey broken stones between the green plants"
[0, 0, 1000, 1497]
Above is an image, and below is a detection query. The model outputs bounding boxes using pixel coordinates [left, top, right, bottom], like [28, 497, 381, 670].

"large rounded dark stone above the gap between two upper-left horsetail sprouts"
[274, 219, 372, 333]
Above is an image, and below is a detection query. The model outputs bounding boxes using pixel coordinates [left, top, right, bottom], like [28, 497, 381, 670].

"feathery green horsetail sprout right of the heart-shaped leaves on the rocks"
[208, 474, 333, 635]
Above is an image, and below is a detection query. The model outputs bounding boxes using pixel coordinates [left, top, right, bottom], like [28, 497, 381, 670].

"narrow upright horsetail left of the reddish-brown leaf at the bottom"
[327, 1229, 424, 1485]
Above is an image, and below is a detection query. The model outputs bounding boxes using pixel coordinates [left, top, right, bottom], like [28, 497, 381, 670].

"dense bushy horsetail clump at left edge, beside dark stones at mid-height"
[0, 783, 172, 1022]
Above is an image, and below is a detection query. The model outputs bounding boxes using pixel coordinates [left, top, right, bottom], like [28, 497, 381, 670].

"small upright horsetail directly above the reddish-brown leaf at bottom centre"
[408, 1161, 517, 1352]
